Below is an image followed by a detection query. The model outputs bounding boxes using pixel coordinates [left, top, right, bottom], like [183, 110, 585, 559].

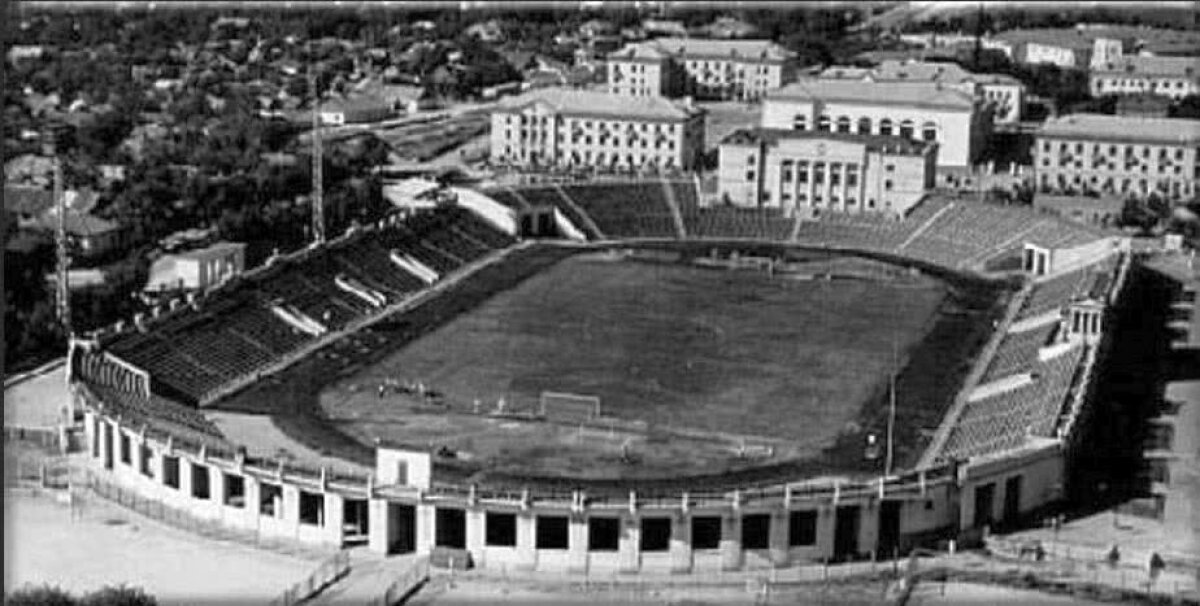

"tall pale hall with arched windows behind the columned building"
[762, 79, 992, 174]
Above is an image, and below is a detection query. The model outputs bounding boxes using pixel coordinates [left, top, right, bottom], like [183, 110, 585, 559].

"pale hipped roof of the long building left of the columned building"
[497, 88, 703, 120]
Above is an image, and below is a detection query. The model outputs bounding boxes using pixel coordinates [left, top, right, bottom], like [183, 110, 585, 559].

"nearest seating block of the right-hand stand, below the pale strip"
[940, 348, 1084, 460]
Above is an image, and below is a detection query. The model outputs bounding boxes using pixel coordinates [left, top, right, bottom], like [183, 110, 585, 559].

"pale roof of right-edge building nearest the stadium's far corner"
[1039, 114, 1200, 145]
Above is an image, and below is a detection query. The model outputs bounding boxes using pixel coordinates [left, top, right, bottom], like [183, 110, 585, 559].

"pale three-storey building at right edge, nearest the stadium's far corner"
[1033, 114, 1200, 199]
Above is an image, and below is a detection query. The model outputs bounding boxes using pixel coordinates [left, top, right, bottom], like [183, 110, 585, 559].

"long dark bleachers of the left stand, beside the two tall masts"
[99, 208, 515, 403]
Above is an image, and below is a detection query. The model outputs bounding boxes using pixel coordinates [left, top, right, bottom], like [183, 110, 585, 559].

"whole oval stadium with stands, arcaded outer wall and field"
[70, 180, 1133, 572]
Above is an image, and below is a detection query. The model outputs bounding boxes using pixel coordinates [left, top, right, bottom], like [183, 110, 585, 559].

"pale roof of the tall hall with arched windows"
[767, 78, 976, 110]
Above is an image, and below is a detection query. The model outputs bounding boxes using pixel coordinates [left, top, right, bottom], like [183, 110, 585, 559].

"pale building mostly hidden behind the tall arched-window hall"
[818, 60, 1025, 124]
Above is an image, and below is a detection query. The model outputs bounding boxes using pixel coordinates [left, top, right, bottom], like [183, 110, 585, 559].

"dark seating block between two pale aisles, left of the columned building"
[562, 181, 678, 238]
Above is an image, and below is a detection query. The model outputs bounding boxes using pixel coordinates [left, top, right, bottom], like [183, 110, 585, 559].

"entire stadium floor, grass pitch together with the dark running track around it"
[220, 245, 1003, 490]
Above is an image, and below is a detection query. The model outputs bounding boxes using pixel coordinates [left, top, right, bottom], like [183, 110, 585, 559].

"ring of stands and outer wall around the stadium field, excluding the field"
[68, 181, 1133, 572]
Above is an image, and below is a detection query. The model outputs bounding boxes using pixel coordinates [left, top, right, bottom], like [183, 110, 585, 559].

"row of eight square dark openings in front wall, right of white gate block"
[446, 508, 817, 553]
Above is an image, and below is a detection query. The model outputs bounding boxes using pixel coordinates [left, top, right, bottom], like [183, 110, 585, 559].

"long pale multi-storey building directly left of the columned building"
[491, 89, 704, 170]
